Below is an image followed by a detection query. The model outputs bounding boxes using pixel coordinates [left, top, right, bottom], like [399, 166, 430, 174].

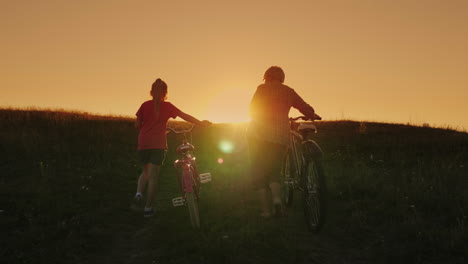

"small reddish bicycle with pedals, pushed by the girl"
[167, 126, 211, 228]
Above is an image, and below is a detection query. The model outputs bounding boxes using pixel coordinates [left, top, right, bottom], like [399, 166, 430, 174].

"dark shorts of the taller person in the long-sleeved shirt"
[248, 138, 287, 189]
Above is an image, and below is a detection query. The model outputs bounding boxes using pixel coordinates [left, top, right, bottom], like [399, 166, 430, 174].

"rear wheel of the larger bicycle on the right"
[302, 157, 327, 233]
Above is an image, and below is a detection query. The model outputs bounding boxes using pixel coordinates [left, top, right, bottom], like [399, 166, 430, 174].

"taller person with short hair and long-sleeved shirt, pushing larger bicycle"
[247, 66, 320, 217]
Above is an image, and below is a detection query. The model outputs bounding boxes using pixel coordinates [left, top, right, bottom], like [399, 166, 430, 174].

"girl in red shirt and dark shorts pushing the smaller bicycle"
[135, 79, 211, 217]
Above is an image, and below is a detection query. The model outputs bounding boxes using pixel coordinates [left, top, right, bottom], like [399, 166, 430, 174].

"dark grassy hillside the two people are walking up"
[0, 110, 468, 264]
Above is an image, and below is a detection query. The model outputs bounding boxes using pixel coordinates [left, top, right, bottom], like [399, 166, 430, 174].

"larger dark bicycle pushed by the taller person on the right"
[282, 116, 327, 233]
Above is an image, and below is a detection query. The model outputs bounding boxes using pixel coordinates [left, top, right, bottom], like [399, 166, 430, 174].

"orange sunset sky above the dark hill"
[0, 0, 468, 130]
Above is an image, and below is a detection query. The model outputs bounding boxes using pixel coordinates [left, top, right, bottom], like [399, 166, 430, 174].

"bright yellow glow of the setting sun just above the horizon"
[207, 88, 253, 123]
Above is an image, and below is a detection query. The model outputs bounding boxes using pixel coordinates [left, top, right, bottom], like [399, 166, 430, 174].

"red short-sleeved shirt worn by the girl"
[136, 100, 181, 149]
